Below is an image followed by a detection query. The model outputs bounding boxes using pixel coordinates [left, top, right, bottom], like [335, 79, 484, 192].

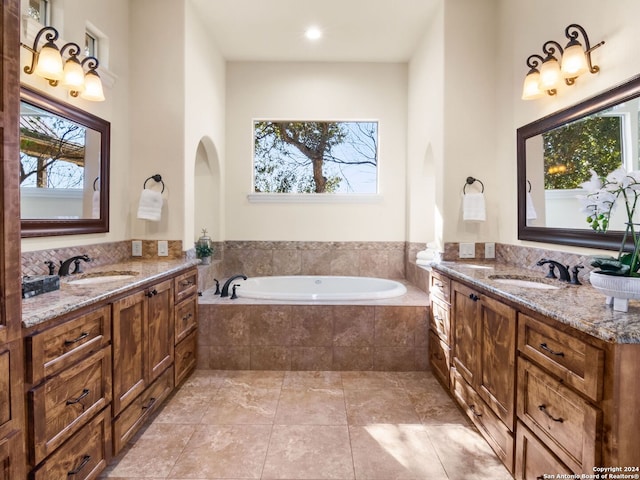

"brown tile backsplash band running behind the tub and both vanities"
[22, 240, 591, 291]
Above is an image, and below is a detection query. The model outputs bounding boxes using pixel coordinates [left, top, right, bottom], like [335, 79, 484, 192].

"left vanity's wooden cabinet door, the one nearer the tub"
[145, 280, 174, 385]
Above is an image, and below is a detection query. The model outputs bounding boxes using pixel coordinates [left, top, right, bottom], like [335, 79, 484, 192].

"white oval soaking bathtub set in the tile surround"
[236, 275, 407, 302]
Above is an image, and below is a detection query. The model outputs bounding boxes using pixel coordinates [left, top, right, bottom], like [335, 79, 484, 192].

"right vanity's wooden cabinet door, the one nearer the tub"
[451, 282, 479, 385]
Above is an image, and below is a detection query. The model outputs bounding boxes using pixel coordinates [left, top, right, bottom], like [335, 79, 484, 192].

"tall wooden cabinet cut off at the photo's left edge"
[0, 0, 26, 480]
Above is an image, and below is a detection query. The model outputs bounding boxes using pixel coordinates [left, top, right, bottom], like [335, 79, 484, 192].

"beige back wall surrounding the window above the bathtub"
[224, 63, 407, 241]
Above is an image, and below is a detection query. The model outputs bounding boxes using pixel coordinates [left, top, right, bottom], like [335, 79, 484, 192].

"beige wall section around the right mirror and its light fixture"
[494, 0, 640, 252]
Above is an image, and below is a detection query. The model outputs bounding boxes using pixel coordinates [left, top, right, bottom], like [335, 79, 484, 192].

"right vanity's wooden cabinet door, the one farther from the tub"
[475, 295, 516, 431]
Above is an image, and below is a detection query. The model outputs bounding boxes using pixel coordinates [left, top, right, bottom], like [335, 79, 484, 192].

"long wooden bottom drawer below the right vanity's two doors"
[451, 368, 515, 472]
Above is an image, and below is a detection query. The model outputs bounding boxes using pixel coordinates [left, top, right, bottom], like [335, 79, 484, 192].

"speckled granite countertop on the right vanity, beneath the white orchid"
[433, 262, 640, 343]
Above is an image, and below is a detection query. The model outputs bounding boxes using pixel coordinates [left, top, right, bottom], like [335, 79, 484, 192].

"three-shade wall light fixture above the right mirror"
[522, 23, 604, 100]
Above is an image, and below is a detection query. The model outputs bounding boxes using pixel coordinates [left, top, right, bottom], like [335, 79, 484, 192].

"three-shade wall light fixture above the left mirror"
[20, 27, 104, 102]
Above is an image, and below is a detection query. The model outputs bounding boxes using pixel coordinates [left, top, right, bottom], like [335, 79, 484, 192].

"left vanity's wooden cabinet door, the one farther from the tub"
[112, 291, 147, 416]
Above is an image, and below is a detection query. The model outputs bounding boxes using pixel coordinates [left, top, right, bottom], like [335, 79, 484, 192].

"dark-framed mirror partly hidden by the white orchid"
[516, 76, 640, 250]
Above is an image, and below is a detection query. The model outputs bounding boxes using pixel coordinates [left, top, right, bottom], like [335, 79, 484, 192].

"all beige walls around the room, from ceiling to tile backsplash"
[21, 0, 640, 255]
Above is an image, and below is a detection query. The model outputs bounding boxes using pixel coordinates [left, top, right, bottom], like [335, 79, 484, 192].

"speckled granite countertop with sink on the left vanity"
[22, 259, 200, 328]
